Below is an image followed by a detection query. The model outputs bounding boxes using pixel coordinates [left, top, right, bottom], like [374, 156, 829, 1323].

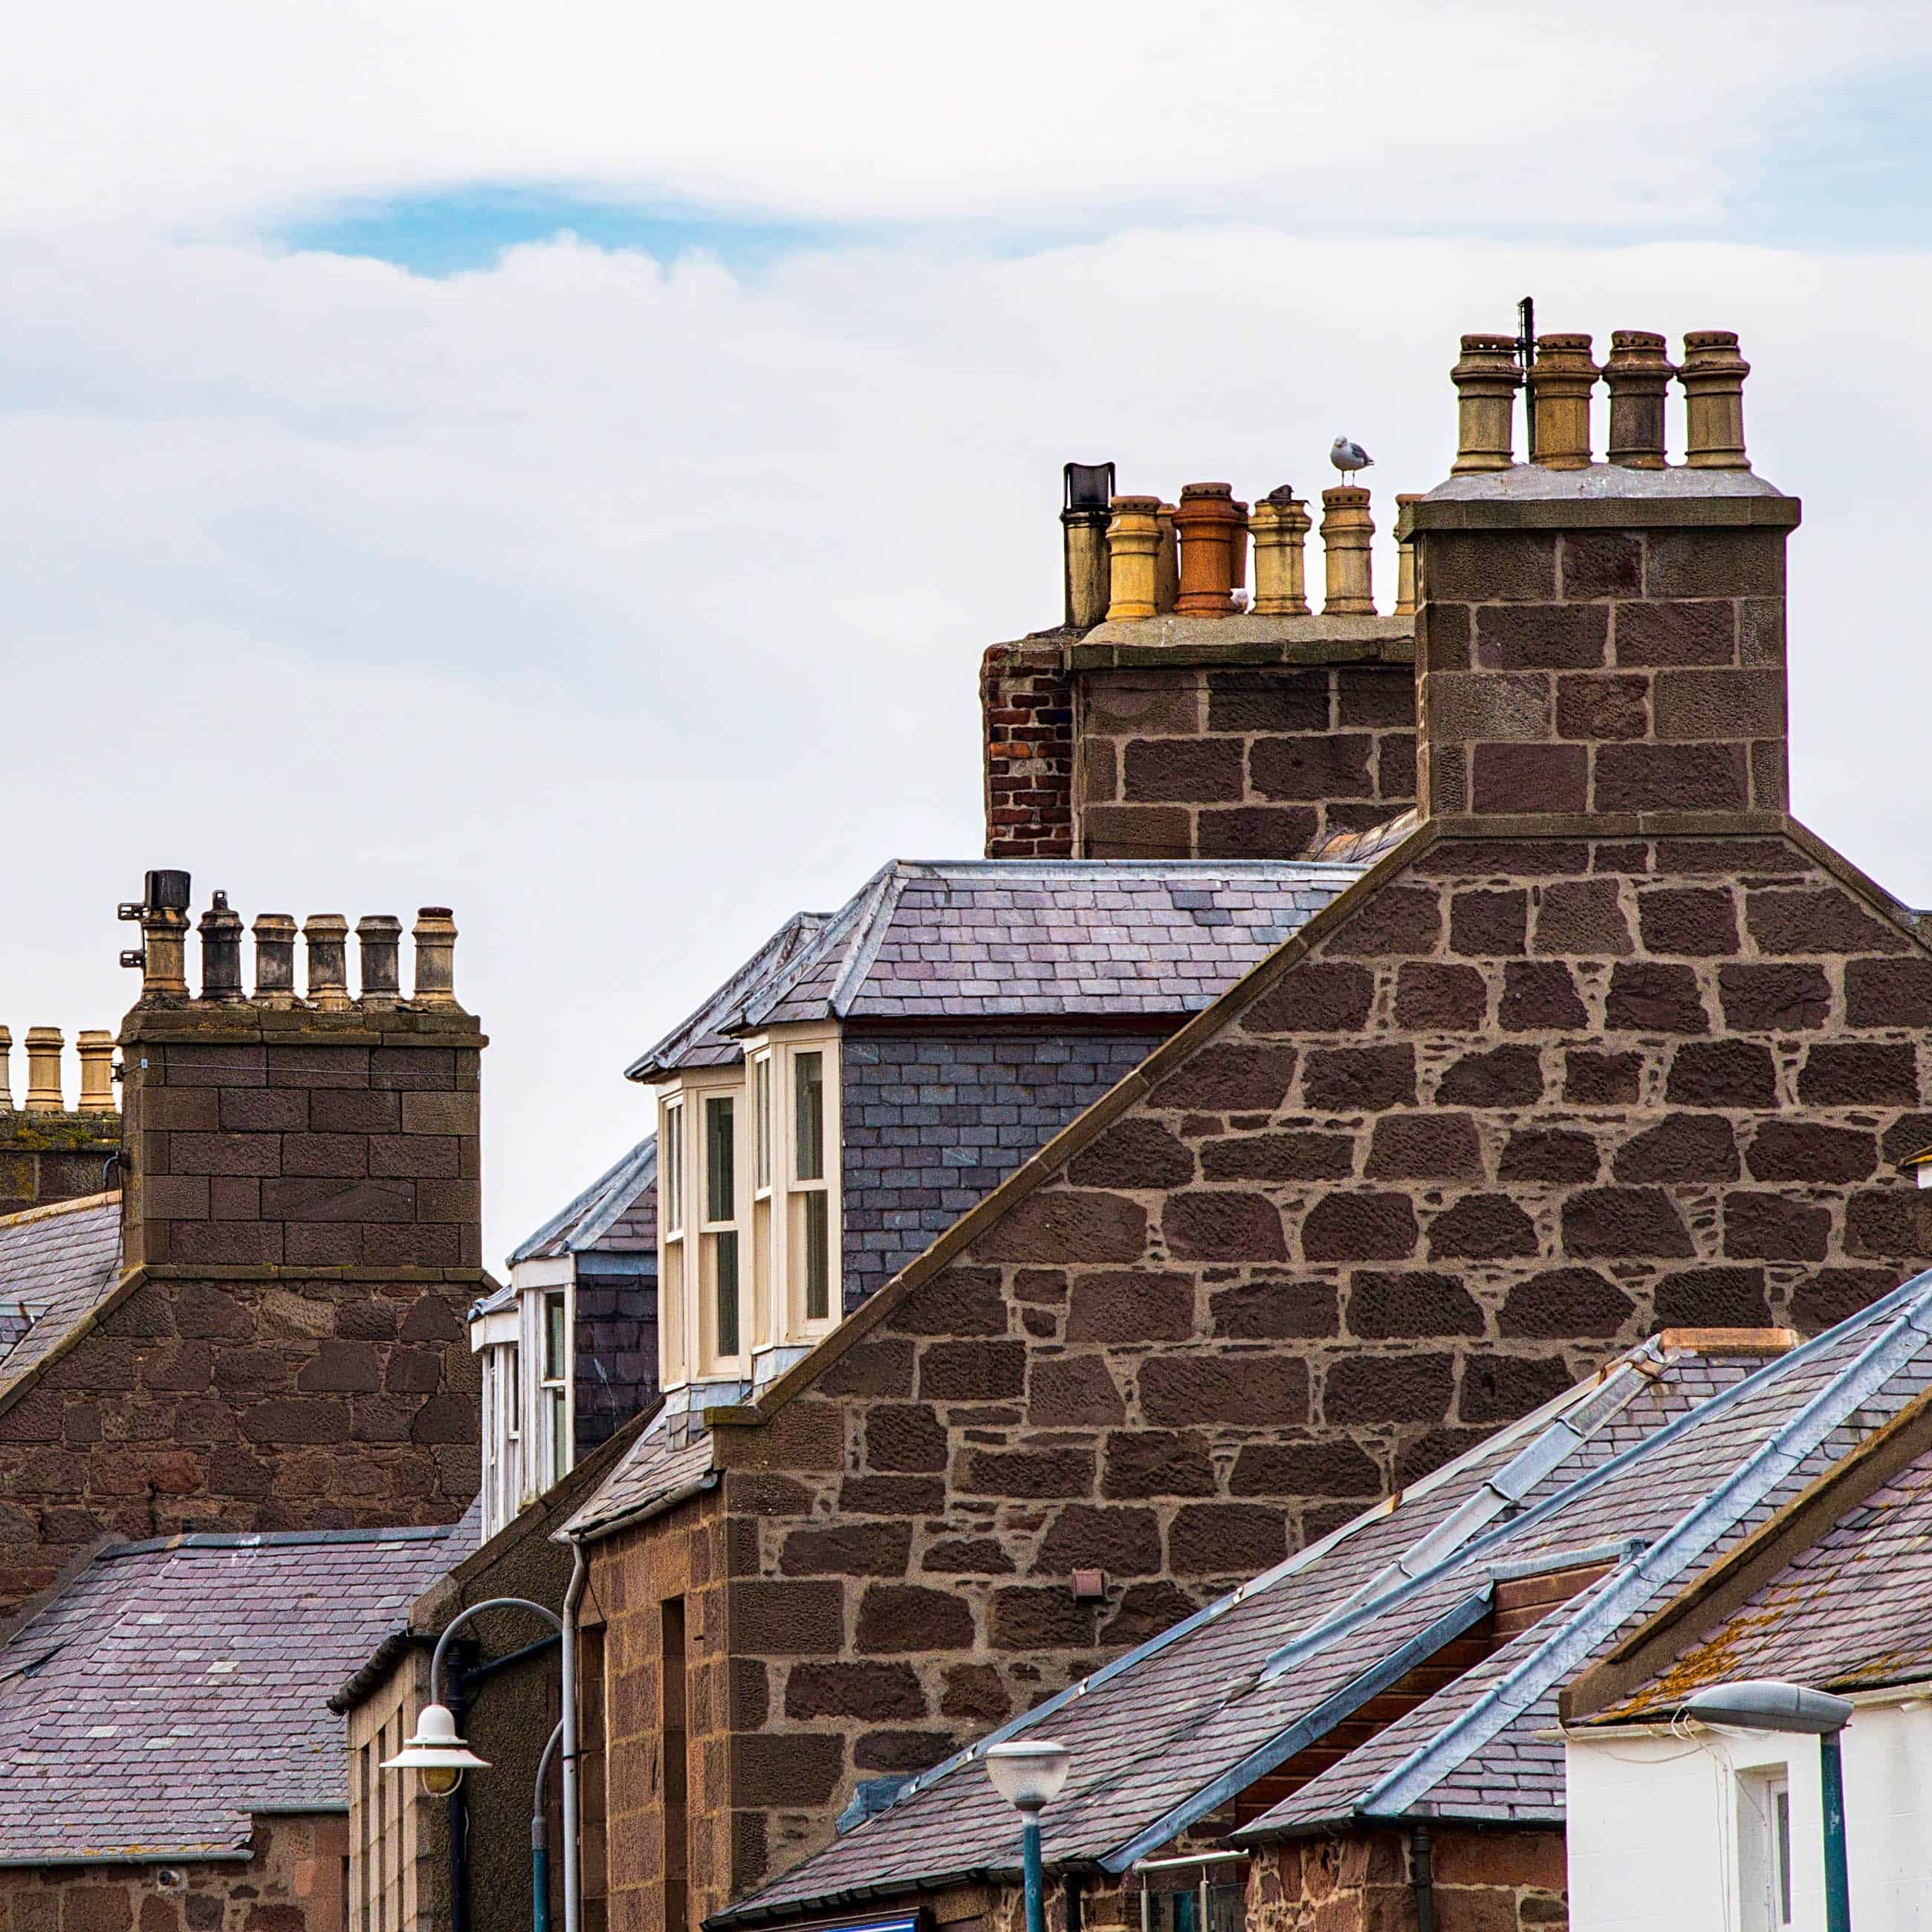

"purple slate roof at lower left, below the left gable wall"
[0, 1524, 473, 1864]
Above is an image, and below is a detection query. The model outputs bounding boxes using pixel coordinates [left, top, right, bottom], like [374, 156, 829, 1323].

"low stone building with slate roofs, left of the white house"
[709, 1273, 1932, 1932]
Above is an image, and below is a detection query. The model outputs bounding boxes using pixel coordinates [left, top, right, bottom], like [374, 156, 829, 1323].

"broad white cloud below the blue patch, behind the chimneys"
[11, 228, 1932, 1256]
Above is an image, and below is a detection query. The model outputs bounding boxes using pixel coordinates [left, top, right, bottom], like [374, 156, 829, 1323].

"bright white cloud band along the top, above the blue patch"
[15, 0, 1932, 234]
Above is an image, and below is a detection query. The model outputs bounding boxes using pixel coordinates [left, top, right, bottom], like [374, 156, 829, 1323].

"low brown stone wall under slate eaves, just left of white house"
[1246, 1826, 1569, 1932]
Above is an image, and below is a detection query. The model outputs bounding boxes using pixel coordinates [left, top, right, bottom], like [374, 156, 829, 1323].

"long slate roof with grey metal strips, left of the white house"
[709, 1273, 1932, 1926]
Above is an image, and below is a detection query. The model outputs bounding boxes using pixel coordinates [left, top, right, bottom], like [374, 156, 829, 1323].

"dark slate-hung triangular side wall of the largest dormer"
[840, 1022, 1169, 1312]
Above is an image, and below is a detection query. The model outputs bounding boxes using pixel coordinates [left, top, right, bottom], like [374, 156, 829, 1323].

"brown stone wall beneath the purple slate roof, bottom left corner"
[0, 1812, 351, 1932]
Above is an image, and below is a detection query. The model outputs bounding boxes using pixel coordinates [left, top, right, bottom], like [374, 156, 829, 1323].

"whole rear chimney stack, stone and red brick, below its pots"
[982, 618, 1416, 860]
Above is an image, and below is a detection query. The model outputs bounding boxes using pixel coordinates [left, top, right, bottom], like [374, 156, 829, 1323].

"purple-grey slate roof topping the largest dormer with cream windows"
[628, 860, 1360, 1080]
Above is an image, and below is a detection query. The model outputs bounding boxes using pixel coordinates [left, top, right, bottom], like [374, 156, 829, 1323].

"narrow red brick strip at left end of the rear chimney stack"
[979, 632, 1076, 858]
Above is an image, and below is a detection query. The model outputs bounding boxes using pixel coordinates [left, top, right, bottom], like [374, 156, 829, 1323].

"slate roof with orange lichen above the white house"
[1594, 1429, 1932, 1723]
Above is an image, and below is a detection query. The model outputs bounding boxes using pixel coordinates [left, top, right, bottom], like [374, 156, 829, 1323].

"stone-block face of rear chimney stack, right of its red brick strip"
[1076, 661, 1416, 858]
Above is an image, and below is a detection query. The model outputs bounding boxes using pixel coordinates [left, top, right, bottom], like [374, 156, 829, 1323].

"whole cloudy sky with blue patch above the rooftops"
[0, 0, 1932, 1263]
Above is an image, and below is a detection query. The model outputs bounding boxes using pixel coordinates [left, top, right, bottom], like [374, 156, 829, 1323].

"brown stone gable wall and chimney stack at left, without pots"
[0, 1005, 487, 1607]
